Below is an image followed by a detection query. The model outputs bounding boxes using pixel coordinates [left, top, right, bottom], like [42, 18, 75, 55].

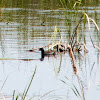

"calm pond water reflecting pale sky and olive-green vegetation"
[0, 0, 100, 100]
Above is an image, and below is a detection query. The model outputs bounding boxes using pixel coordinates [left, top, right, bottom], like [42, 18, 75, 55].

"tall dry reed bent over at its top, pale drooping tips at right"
[69, 13, 99, 51]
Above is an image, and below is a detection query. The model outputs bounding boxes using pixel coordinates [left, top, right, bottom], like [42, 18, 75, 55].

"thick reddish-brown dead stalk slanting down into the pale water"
[67, 44, 78, 75]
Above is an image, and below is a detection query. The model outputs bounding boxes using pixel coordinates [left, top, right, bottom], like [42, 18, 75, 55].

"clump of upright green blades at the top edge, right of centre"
[60, 0, 82, 30]
